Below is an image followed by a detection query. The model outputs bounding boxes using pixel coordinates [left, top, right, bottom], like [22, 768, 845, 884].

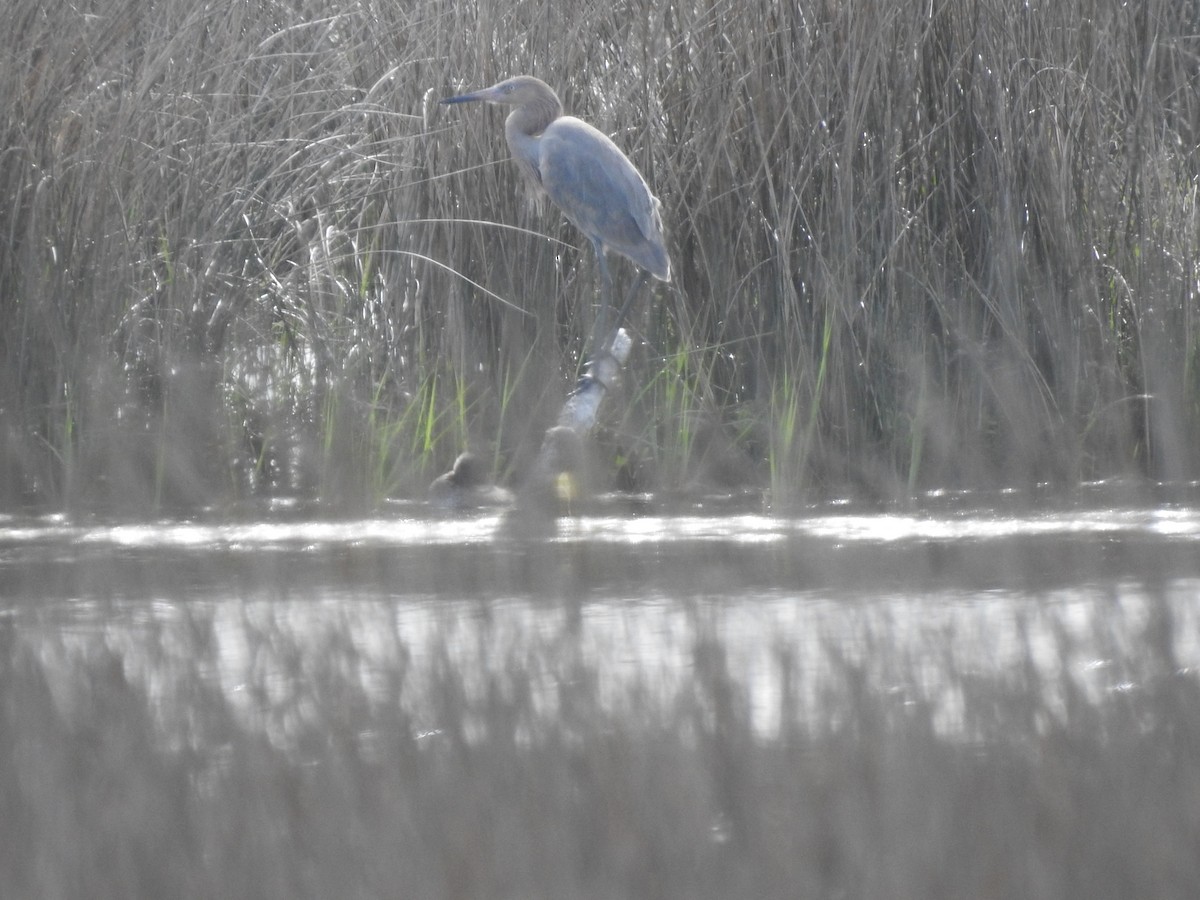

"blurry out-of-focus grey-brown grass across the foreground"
[0, 598, 1200, 900]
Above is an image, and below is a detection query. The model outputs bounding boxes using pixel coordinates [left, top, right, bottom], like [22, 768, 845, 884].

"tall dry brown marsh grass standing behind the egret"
[0, 0, 1200, 510]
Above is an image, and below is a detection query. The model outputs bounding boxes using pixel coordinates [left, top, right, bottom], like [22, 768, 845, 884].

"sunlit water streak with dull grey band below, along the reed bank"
[9, 496, 1200, 602]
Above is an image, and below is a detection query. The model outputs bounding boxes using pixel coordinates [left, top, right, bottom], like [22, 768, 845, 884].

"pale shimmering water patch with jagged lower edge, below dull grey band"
[49, 581, 1200, 733]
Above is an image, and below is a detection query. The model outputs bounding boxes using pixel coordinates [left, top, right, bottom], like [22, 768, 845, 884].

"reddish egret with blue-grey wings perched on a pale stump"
[442, 76, 671, 356]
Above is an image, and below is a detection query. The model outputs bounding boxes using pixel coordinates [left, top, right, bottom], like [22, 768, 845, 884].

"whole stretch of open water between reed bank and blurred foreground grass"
[0, 508, 1200, 742]
